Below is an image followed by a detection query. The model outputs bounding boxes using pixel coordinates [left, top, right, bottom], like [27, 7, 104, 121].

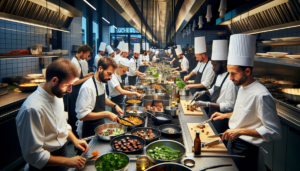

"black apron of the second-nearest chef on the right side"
[208, 73, 229, 133]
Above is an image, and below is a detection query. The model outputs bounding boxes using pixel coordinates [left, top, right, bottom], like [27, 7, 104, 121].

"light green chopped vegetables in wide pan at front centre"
[147, 145, 182, 160]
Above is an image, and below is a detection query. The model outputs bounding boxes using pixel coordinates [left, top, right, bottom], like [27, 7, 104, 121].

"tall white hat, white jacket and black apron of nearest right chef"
[227, 34, 281, 171]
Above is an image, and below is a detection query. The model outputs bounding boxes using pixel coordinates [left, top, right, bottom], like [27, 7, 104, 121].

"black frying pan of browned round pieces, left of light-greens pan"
[110, 135, 146, 154]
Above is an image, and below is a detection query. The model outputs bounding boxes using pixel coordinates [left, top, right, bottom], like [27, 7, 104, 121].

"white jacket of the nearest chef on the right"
[228, 81, 281, 145]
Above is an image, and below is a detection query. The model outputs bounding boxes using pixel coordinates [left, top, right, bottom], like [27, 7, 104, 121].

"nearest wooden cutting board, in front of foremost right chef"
[187, 123, 227, 152]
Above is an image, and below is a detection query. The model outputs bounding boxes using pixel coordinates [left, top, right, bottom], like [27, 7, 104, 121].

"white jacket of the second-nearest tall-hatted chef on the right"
[208, 72, 239, 112]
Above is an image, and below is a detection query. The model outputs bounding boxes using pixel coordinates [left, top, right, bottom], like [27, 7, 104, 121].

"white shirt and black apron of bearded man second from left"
[76, 76, 107, 137]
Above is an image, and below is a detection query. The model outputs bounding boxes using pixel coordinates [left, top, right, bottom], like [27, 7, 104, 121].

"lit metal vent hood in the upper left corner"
[0, 0, 82, 32]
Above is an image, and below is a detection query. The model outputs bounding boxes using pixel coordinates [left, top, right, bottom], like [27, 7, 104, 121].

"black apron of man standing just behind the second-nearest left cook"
[68, 57, 83, 138]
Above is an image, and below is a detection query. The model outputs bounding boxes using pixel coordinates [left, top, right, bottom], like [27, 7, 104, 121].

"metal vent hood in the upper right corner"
[217, 0, 300, 34]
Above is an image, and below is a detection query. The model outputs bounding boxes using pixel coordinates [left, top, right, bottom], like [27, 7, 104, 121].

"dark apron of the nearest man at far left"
[29, 143, 69, 171]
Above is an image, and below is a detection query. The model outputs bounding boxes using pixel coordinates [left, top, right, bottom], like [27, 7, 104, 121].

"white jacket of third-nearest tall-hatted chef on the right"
[193, 61, 215, 88]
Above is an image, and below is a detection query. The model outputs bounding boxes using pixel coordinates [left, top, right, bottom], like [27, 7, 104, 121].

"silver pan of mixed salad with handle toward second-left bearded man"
[82, 123, 127, 141]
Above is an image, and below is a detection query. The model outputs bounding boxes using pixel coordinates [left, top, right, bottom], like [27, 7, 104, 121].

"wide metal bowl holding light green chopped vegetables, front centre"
[146, 140, 186, 164]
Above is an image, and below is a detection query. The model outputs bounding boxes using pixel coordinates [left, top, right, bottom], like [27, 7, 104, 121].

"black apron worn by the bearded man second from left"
[82, 76, 105, 138]
